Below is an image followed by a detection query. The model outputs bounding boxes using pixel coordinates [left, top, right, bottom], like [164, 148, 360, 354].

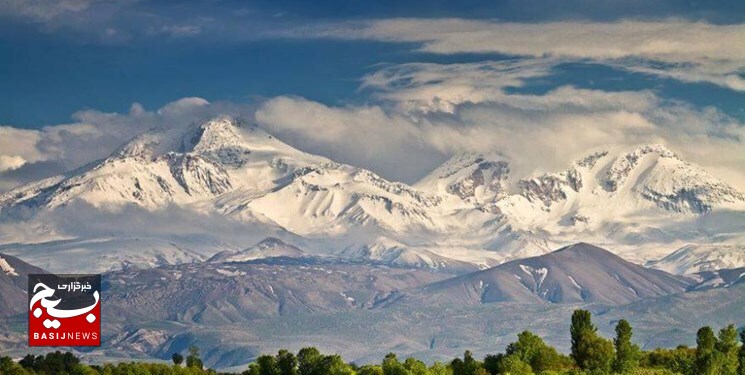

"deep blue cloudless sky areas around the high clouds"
[0, 1, 745, 127]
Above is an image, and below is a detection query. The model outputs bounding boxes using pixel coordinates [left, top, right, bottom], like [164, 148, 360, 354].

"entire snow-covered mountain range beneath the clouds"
[0, 117, 745, 271]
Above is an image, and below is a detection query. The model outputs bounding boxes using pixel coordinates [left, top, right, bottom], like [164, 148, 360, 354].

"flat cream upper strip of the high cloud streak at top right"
[348, 19, 745, 62]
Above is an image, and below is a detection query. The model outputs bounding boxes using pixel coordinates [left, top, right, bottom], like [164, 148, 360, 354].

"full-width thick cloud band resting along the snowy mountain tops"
[0, 59, 745, 189]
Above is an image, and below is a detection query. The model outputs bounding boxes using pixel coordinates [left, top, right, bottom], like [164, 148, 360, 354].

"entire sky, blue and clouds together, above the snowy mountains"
[0, 0, 745, 190]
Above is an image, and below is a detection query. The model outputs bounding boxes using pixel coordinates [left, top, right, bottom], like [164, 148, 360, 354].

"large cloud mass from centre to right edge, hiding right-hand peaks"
[256, 61, 745, 188]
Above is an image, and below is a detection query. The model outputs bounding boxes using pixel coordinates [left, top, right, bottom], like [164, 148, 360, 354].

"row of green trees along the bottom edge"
[0, 310, 745, 375]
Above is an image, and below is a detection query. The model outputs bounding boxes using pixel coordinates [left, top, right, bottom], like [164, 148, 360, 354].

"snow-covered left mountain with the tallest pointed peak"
[0, 117, 464, 269]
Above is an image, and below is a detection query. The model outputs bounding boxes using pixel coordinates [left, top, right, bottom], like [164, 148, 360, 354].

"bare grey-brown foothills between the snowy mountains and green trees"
[0, 244, 745, 369]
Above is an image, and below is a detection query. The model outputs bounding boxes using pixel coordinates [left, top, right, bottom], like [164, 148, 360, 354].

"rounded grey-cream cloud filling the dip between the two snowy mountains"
[255, 97, 444, 182]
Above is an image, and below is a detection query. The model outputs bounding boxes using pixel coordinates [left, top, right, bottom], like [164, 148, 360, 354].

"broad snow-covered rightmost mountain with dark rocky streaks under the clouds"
[476, 145, 745, 262]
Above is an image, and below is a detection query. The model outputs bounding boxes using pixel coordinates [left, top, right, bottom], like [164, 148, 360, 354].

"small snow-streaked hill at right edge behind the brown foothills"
[646, 244, 745, 275]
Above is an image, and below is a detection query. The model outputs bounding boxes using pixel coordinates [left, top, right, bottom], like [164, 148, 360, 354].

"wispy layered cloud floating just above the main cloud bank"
[362, 58, 656, 113]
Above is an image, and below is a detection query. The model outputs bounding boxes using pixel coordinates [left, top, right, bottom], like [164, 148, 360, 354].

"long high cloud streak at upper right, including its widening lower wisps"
[284, 18, 745, 91]
